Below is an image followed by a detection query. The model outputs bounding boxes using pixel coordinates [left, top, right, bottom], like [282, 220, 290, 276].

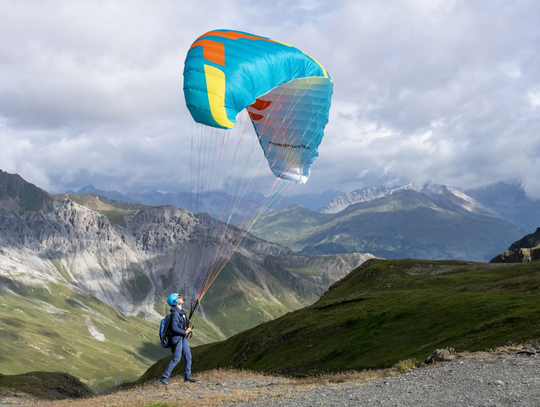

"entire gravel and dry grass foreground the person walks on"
[4, 352, 540, 407]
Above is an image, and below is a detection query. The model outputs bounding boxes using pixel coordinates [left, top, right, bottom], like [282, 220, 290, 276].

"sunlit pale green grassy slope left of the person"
[0, 281, 171, 390]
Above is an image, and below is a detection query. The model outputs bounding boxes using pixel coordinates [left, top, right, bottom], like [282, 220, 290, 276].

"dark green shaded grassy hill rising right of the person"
[136, 259, 540, 380]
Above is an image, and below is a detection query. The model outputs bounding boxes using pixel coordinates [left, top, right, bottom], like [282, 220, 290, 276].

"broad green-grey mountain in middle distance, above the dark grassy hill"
[252, 185, 524, 261]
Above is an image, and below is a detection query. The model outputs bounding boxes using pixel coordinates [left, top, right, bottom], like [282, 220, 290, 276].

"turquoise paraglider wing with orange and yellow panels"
[184, 30, 333, 183]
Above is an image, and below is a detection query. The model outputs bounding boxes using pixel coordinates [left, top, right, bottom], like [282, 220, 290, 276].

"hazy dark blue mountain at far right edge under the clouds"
[465, 182, 540, 230]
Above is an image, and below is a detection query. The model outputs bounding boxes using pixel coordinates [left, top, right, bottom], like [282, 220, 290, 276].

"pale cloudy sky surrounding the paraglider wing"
[0, 0, 540, 198]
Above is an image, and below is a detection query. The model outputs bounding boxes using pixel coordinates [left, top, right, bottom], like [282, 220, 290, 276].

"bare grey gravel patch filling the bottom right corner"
[236, 354, 540, 407]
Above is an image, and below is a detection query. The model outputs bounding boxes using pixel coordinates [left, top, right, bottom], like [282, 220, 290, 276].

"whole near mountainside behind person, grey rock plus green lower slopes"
[0, 172, 372, 389]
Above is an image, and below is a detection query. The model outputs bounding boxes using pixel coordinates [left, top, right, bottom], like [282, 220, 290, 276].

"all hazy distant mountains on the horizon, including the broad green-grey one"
[66, 182, 540, 261]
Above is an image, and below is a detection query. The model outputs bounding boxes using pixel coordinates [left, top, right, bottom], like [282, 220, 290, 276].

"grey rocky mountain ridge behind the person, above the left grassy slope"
[0, 172, 371, 340]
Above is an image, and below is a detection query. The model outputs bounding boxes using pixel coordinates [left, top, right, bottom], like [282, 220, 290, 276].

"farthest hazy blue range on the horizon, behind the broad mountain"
[68, 182, 540, 231]
